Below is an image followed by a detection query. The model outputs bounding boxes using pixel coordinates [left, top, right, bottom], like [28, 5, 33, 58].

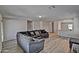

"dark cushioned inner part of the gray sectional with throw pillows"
[17, 30, 49, 38]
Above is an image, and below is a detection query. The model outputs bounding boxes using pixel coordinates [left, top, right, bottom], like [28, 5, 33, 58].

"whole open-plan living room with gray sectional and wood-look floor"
[0, 5, 79, 53]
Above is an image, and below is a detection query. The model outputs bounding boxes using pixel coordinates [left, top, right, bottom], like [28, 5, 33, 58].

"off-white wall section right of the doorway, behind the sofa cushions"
[33, 21, 52, 32]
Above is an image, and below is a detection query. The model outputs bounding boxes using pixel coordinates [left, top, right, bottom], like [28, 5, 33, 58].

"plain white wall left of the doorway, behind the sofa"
[4, 19, 27, 41]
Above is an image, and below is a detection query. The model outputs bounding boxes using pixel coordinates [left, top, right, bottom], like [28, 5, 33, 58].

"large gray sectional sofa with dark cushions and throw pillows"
[17, 30, 49, 53]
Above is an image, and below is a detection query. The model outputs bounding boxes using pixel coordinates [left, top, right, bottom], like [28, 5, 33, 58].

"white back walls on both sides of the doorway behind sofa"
[3, 19, 52, 41]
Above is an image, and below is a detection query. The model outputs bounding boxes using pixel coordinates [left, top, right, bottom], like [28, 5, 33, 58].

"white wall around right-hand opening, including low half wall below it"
[58, 17, 79, 36]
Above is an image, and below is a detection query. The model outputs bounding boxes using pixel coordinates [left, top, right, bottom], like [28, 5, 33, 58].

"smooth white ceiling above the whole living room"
[0, 5, 79, 20]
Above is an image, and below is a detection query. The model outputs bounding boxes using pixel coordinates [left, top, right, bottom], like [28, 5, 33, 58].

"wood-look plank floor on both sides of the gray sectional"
[2, 33, 69, 53]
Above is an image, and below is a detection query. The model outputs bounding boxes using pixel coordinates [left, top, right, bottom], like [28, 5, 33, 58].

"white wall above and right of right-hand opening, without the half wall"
[58, 17, 79, 33]
